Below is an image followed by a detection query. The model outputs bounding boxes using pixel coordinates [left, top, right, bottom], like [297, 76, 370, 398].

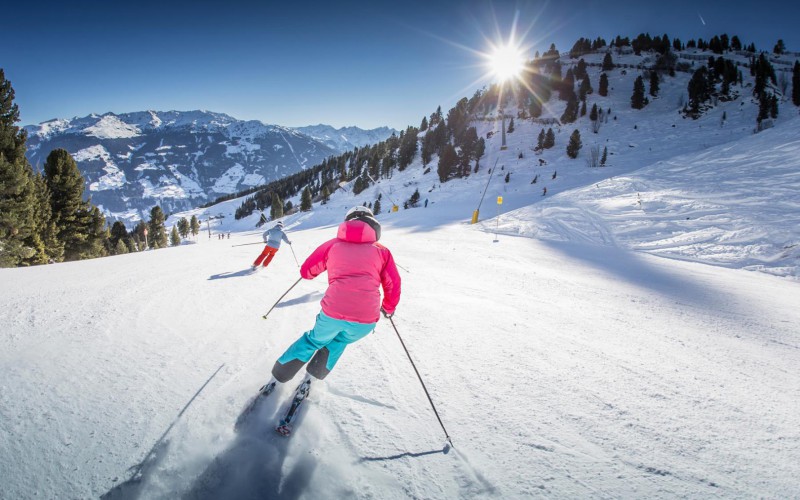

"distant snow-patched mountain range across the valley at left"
[25, 111, 393, 225]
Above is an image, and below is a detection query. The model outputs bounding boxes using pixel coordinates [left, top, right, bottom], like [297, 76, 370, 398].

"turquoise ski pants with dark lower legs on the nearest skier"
[272, 311, 376, 382]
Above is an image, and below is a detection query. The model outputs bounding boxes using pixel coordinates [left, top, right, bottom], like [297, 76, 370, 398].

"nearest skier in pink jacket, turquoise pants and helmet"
[261, 206, 400, 394]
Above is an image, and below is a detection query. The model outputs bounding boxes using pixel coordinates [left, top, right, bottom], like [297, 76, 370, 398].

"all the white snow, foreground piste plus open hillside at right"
[0, 47, 800, 499]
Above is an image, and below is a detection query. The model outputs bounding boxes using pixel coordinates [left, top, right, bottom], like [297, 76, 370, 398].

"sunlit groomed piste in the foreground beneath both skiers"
[0, 190, 800, 498]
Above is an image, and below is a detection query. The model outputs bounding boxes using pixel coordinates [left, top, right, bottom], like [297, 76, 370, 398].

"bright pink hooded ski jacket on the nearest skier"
[300, 220, 400, 323]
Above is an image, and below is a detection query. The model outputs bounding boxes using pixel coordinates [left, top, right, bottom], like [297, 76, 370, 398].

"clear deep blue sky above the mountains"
[0, 0, 800, 128]
